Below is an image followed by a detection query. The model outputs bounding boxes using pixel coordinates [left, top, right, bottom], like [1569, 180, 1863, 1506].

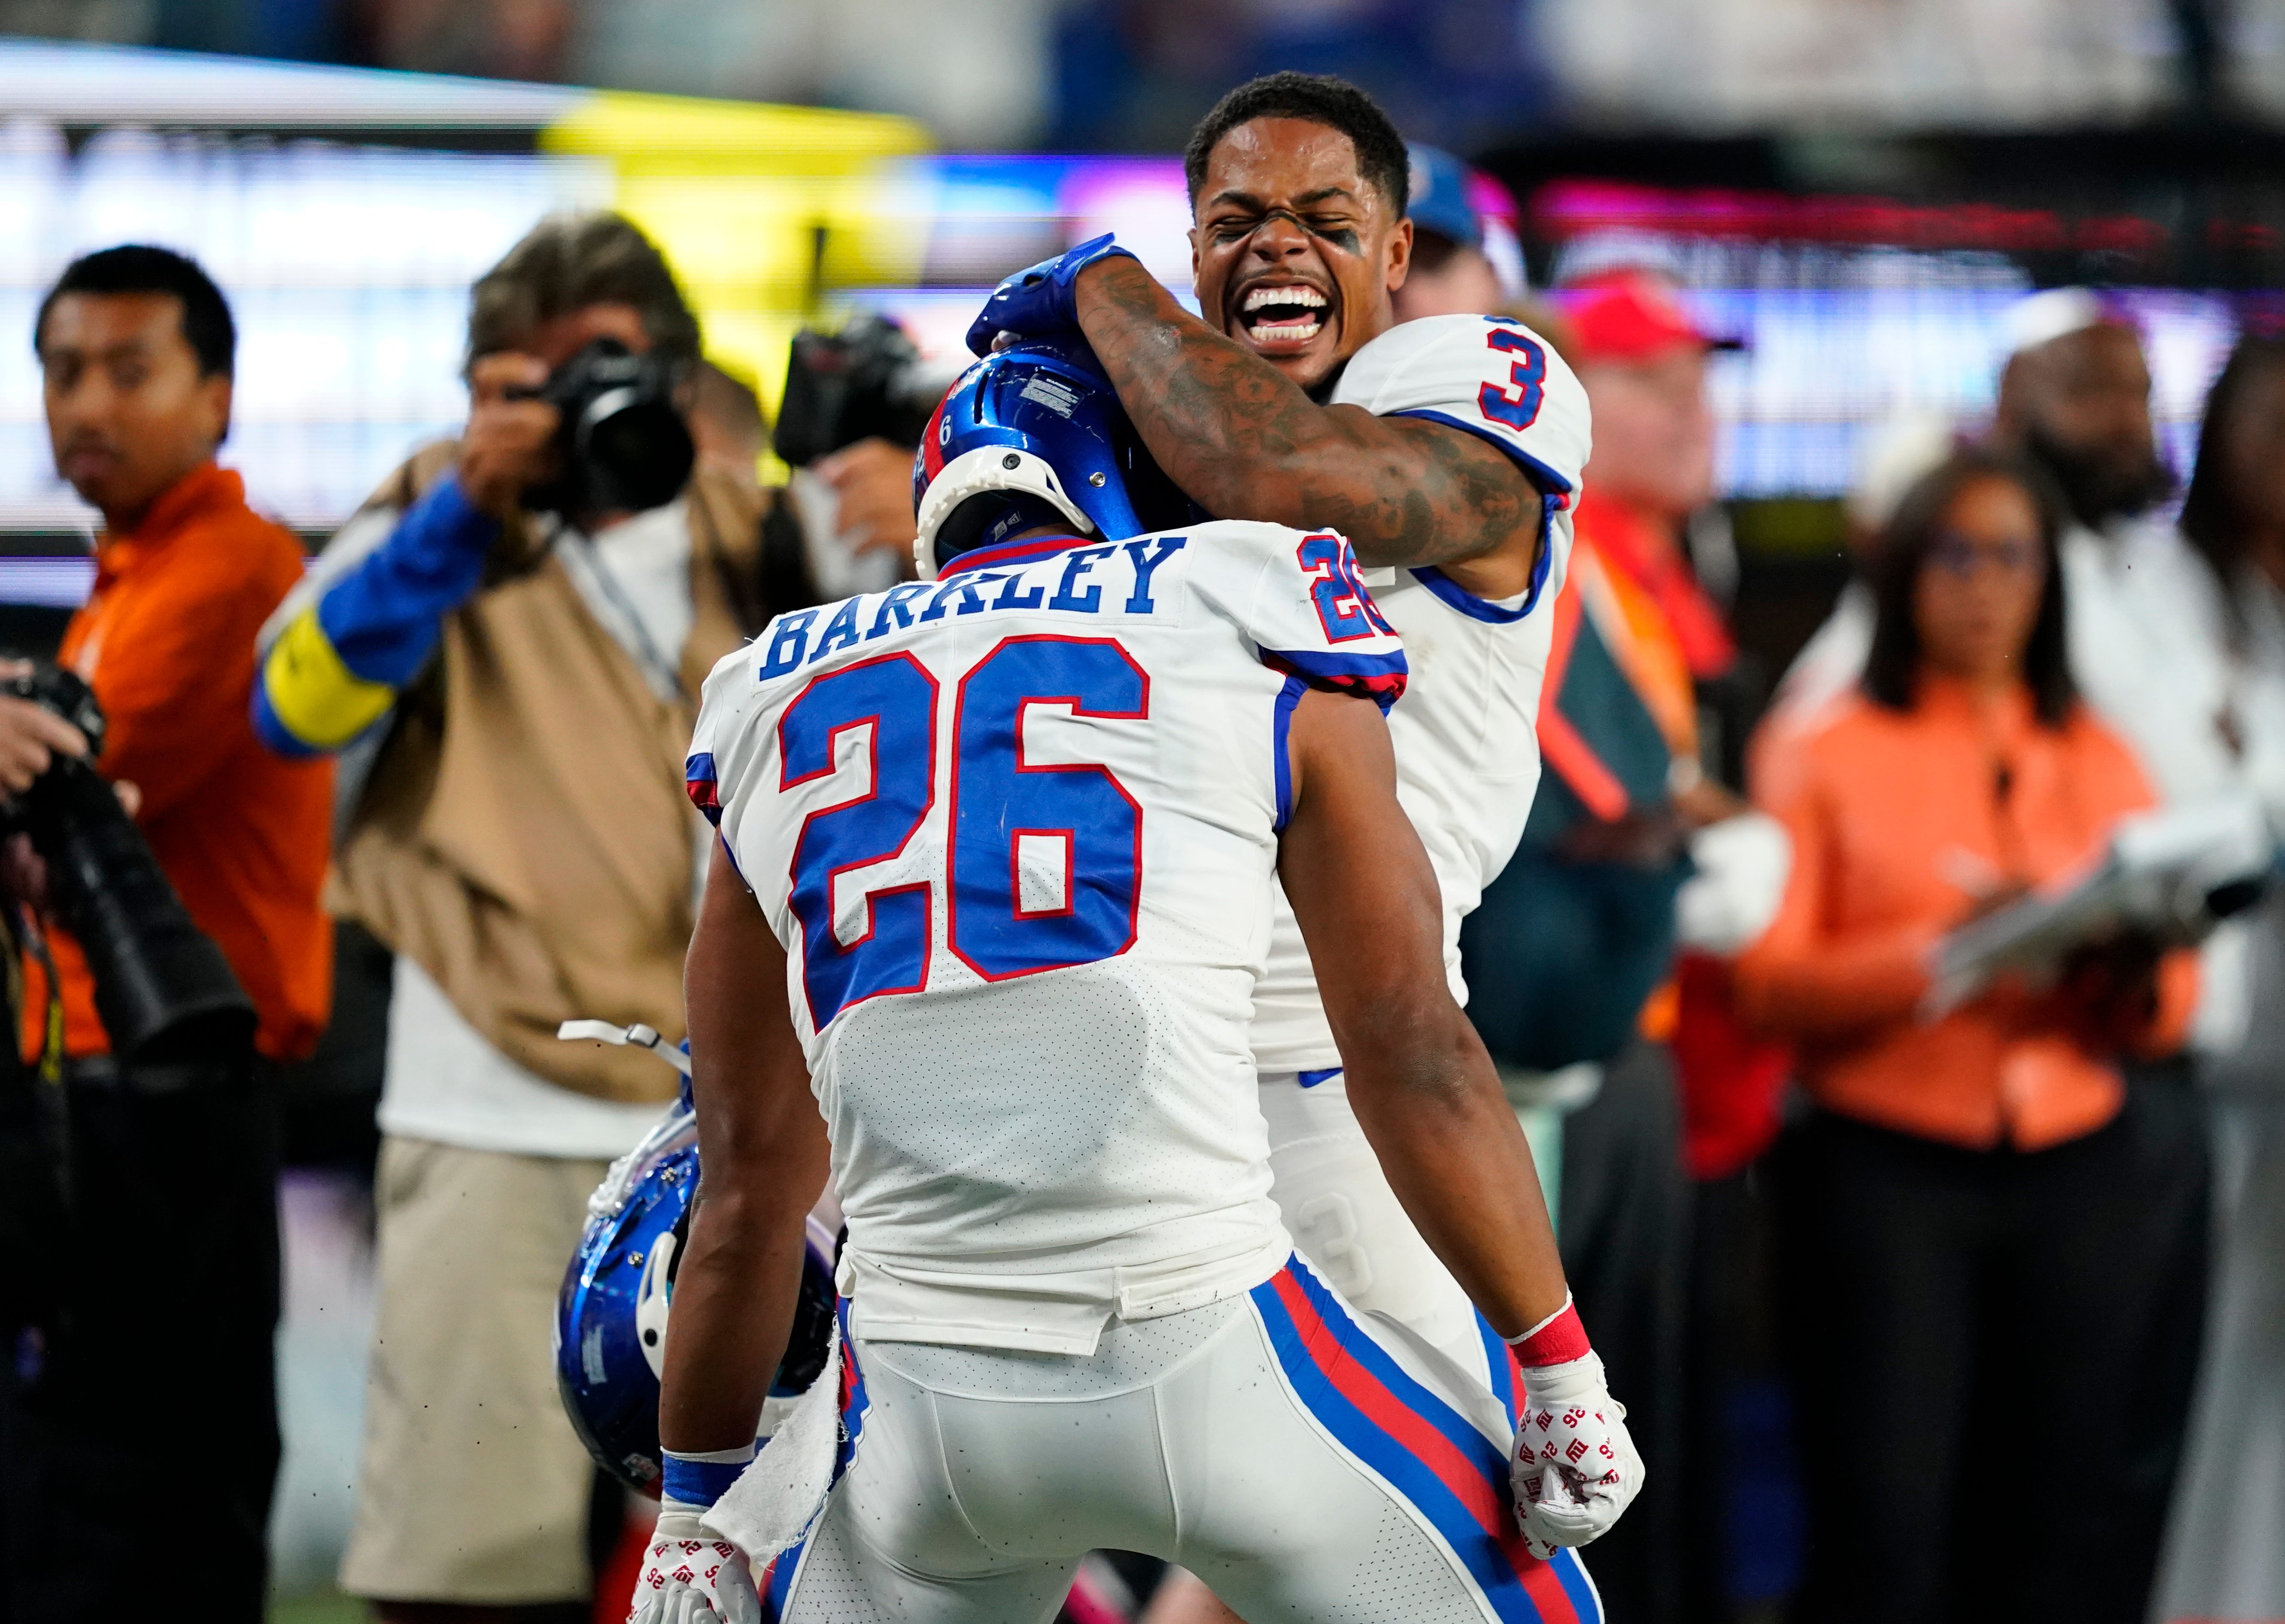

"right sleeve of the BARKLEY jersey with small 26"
[1193, 523, 1405, 710]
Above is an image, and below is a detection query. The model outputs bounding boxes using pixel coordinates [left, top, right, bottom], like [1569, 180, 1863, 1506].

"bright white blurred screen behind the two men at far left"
[0, 123, 608, 530]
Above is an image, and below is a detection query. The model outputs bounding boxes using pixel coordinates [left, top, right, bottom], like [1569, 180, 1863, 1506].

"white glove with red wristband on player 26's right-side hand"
[1508, 1297, 1643, 1562]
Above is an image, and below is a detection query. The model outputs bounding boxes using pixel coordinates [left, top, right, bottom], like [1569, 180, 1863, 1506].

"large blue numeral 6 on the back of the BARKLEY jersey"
[948, 637, 1149, 982]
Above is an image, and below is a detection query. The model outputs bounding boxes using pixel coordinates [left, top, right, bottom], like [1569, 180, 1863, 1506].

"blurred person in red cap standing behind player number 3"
[1462, 267, 1787, 1619]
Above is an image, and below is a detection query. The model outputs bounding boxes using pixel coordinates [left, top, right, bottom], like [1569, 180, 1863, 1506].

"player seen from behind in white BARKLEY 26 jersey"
[635, 335, 1638, 1624]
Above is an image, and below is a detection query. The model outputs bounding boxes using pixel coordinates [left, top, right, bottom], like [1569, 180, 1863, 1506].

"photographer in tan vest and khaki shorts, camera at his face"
[254, 213, 813, 1619]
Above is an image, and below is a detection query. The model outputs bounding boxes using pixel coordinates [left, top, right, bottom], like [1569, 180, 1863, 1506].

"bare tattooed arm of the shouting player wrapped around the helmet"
[1079, 258, 1540, 569]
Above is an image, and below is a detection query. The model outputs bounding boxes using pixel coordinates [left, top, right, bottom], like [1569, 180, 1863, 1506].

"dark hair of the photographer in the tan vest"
[468, 210, 699, 365]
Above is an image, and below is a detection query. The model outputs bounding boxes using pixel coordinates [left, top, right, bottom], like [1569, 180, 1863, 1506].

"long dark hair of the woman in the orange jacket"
[1865, 445, 2079, 729]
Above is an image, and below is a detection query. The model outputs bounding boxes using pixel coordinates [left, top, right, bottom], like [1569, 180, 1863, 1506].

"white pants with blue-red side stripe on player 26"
[757, 1259, 1602, 1624]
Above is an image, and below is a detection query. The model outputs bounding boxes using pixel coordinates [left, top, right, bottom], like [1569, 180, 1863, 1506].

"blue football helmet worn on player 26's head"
[912, 338, 1206, 580]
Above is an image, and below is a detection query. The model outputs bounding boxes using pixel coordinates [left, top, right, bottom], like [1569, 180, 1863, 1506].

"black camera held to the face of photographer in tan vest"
[526, 338, 697, 518]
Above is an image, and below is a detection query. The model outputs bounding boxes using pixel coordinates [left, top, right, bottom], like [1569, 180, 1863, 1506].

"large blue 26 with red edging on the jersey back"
[777, 637, 1149, 1028]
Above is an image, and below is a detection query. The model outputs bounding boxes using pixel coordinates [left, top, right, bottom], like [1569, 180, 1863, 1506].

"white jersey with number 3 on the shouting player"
[1252, 315, 1588, 1076]
